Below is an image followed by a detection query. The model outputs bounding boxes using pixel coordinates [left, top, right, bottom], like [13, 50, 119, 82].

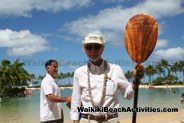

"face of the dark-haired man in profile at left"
[47, 62, 58, 78]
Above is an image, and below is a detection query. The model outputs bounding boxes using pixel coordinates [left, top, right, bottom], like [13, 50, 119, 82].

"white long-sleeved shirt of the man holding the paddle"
[70, 62, 134, 120]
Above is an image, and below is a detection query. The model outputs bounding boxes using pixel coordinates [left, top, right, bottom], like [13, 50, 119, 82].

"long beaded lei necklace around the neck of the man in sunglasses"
[87, 60, 107, 107]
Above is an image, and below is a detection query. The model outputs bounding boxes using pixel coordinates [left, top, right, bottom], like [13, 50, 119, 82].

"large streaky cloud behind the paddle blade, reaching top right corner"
[62, 0, 184, 45]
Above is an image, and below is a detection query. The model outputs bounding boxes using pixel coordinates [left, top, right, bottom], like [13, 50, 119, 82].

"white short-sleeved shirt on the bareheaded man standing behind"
[40, 74, 61, 121]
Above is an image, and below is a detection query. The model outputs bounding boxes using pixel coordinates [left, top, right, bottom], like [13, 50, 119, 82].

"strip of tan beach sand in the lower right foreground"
[120, 109, 184, 123]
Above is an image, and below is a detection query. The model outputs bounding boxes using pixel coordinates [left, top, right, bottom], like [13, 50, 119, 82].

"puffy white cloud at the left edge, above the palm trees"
[0, 29, 50, 56]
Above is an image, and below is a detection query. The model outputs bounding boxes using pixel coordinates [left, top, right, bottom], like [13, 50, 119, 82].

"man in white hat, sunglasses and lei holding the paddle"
[70, 34, 144, 123]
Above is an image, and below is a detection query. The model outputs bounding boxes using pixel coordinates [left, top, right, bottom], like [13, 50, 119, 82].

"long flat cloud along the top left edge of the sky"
[0, 0, 91, 18]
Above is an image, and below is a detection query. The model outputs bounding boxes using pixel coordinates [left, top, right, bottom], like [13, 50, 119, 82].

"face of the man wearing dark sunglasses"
[84, 43, 104, 62]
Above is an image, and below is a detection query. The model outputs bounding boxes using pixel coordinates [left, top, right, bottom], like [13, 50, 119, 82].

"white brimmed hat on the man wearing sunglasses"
[82, 33, 105, 45]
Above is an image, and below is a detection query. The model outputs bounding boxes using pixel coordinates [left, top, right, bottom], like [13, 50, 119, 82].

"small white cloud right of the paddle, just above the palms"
[154, 47, 184, 60]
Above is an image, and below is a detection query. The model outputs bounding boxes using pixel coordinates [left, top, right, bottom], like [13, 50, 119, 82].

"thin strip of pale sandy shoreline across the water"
[26, 85, 184, 90]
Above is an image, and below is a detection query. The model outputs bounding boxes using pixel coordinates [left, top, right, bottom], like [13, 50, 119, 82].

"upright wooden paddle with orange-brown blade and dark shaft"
[124, 14, 158, 123]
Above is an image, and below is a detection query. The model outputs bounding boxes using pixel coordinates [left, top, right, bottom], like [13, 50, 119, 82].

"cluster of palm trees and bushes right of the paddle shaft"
[141, 59, 184, 85]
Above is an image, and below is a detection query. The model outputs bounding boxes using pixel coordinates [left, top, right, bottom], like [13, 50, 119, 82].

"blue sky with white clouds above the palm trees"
[0, 0, 184, 76]
